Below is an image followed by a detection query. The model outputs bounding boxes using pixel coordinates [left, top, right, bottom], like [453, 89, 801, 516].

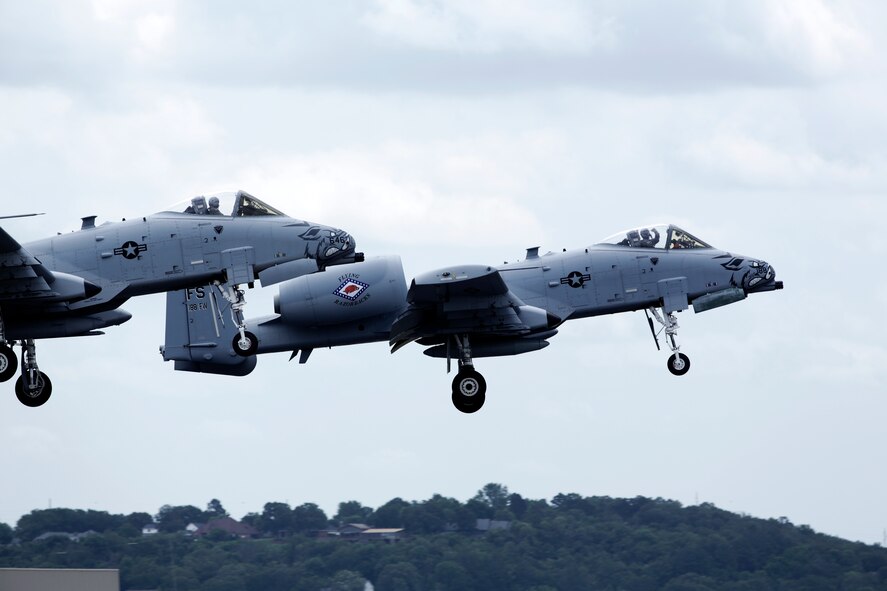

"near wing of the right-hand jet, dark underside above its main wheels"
[389, 265, 547, 353]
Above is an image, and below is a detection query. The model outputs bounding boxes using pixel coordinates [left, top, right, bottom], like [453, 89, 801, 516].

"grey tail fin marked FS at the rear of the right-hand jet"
[160, 286, 256, 376]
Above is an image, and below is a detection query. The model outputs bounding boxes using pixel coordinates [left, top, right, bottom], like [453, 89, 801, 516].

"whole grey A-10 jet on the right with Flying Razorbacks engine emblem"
[161, 224, 783, 413]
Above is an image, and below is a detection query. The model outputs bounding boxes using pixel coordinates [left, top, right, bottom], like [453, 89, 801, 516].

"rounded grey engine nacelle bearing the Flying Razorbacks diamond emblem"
[274, 256, 407, 327]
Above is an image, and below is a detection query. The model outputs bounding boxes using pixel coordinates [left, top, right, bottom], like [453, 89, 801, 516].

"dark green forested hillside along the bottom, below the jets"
[0, 484, 887, 591]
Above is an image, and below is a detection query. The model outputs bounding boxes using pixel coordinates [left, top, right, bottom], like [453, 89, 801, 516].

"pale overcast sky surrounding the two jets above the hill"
[0, 0, 887, 543]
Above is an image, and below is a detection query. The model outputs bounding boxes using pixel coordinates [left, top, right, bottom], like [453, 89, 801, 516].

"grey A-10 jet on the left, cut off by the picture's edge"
[0, 191, 362, 406]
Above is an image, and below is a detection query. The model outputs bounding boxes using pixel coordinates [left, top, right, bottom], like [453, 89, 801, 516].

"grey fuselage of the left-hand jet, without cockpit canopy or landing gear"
[4, 212, 354, 340]
